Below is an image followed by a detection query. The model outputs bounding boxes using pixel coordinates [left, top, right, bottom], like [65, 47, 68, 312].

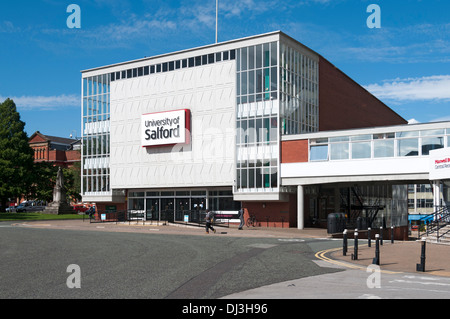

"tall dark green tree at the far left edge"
[0, 99, 34, 210]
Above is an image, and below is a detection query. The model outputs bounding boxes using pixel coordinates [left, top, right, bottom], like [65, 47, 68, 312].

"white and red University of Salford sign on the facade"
[140, 109, 191, 147]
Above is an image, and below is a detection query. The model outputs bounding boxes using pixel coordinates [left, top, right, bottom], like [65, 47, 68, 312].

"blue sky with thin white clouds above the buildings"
[0, 0, 450, 137]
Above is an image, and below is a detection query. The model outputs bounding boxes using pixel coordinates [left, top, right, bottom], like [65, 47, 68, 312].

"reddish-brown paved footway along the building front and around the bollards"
[13, 220, 450, 277]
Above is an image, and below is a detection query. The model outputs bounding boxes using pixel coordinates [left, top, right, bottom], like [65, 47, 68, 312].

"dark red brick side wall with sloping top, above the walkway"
[319, 58, 407, 131]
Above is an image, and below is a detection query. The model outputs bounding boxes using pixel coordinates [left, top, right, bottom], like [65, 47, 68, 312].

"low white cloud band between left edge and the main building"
[0, 94, 81, 110]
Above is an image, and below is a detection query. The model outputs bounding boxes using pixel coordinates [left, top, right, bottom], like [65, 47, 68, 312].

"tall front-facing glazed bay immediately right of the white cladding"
[235, 42, 279, 192]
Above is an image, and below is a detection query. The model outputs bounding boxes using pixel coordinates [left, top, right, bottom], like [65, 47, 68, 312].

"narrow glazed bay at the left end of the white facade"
[82, 74, 110, 195]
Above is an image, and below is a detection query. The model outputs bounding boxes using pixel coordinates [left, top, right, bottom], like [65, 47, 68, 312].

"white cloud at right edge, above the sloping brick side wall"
[365, 75, 450, 102]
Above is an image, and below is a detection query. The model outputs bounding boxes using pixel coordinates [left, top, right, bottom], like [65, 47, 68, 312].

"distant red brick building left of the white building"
[28, 131, 81, 168]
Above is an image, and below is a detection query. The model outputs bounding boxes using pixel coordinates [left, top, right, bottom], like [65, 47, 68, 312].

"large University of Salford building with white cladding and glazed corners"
[82, 32, 422, 228]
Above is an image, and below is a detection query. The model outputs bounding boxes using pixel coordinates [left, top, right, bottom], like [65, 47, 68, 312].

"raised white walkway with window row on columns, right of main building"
[280, 122, 450, 229]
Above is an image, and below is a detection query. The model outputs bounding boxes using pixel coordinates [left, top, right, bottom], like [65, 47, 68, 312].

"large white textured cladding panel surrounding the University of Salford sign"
[110, 61, 236, 189]
